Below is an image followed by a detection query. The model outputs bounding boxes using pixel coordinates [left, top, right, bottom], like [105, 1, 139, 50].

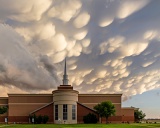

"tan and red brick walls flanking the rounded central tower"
[0, 92, 134, 123]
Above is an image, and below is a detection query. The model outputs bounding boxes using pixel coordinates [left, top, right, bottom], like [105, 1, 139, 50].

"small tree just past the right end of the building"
[134, 110, 146, 122]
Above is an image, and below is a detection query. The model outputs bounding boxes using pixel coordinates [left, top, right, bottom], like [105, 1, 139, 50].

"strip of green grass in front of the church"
[0, 124, 160, 128]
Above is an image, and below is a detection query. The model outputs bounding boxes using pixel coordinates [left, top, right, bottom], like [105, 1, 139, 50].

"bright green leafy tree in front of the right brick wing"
[94, 101, 116, 123]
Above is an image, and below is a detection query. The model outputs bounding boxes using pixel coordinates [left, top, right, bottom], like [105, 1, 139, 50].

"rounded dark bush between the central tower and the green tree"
[83, 113, 98, 124]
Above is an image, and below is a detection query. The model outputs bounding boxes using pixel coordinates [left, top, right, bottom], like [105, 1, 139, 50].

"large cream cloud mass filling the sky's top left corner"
[0, 0, 52, 22]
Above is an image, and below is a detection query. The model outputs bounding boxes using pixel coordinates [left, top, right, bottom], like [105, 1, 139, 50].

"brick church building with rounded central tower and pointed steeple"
[0, 60, 134, 124]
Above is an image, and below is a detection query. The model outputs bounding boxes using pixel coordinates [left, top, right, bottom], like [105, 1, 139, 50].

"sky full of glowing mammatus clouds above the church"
[0, 0, 160, 118]
